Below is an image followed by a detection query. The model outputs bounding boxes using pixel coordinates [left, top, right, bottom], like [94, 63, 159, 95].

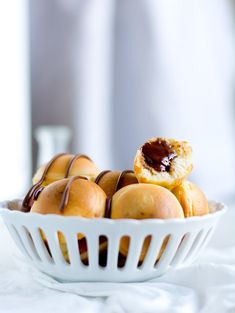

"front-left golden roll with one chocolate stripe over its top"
[30, 176, 107, 261]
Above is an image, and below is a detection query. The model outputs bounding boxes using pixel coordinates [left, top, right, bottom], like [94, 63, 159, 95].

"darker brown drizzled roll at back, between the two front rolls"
[95, 170, 138, 198]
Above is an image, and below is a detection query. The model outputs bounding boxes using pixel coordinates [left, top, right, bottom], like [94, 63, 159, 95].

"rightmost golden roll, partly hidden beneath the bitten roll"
[172, 181, 209, 217]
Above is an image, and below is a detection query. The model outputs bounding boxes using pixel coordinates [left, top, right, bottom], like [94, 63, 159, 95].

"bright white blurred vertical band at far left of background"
[0, 0, 31, 200]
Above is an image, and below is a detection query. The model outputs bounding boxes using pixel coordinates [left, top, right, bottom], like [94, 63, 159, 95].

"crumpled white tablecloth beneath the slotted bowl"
[0, 207, 235, 313]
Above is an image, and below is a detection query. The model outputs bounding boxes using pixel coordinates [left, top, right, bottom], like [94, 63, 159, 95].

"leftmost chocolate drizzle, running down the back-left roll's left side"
[21, 153, 66, 212]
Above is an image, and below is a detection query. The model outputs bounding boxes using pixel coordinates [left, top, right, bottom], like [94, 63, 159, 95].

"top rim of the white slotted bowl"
[0, 199, 227, 225]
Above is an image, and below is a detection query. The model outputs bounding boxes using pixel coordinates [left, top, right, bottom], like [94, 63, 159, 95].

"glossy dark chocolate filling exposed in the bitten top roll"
[141, 139, 177, 172]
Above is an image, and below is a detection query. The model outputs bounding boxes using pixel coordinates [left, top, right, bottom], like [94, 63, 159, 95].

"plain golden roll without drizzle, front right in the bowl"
[111, 184, 184, 261]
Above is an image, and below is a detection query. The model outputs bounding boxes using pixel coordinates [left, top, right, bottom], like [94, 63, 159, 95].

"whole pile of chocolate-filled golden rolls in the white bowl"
[21, 137, 209, 262]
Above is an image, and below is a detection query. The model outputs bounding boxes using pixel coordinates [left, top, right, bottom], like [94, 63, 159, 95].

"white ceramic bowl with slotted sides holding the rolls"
[0, 202, 225, 282]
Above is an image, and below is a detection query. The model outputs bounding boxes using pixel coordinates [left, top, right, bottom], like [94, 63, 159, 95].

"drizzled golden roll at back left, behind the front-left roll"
[33, 153, 100, 186]
